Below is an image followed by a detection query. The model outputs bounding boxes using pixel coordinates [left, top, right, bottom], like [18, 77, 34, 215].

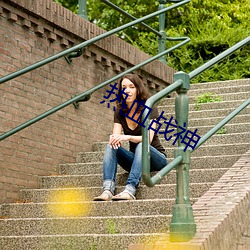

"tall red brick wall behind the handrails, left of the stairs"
[0, 0, 173, 203]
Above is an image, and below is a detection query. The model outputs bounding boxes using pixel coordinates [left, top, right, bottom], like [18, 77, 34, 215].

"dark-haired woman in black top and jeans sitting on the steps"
[94, 74, 168, 201]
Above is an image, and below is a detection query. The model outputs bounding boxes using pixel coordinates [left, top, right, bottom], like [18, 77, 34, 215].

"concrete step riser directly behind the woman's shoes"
[20, 182, 213, 203]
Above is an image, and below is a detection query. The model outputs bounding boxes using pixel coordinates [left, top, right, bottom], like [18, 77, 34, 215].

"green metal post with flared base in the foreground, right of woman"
[170, 72, 196, 242]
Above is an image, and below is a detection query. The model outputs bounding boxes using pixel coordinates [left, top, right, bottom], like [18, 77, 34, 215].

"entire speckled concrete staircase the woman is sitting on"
[0, 80, 250, 250]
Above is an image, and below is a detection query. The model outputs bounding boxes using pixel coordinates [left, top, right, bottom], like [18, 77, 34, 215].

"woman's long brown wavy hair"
[117, 74, 149, 114]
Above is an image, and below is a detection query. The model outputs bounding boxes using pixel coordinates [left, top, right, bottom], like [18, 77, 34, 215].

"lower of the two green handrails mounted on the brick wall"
[0, 38, 190, 141]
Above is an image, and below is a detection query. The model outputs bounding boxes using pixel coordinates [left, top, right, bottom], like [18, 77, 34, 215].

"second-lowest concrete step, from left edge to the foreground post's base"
[0, 215, 171, 236]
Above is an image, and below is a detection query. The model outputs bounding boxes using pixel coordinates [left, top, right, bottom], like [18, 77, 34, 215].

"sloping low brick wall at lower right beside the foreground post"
[129, 150, 250, 250]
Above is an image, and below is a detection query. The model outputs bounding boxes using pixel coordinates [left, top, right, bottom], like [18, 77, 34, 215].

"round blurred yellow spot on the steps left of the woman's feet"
[48, 189, 90, 217]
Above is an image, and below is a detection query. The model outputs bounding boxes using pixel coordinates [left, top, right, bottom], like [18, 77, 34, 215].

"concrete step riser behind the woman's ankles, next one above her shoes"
[40, 168, 228, 188]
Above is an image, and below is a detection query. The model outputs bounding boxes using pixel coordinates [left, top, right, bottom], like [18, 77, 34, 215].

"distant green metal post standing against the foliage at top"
[158, 0, 167, 64]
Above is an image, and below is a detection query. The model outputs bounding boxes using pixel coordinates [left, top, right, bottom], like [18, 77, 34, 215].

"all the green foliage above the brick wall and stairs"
[54, 0, 250, 83]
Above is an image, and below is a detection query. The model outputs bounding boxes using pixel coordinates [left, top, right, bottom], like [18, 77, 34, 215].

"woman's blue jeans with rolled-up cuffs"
[103, 143, 168, 195]
